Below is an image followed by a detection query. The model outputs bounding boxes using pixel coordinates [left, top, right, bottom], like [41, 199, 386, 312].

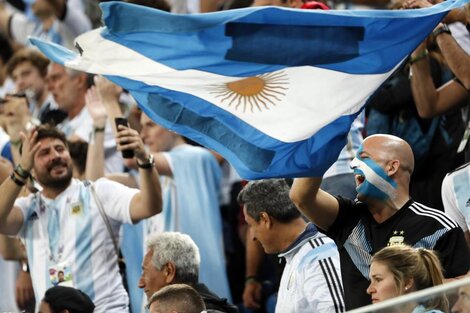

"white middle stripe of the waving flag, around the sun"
[65, 29, 400, 142]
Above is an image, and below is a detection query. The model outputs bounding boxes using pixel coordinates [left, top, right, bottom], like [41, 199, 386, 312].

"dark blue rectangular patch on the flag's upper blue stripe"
[225, 23, 364, 66]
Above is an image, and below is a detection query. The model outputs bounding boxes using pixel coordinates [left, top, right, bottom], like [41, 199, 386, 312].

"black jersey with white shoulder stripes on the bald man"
[327, 197, 470, 310]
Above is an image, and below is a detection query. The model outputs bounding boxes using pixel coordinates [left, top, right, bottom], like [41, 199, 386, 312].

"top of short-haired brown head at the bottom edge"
[148, 284, 206, 313]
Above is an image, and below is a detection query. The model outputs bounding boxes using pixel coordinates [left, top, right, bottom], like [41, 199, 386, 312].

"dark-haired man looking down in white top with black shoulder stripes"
[238, 179, 345, 313]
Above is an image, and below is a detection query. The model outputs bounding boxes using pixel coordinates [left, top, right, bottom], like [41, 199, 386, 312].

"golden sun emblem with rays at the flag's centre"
[210, 72, 289, 112]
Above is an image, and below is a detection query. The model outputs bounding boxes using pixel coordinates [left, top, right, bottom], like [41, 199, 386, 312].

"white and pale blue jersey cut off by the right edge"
[442, 163, 470, 231]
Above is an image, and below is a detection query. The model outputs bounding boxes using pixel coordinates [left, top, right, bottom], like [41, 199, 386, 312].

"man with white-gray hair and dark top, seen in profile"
[139, 232, 238, 313]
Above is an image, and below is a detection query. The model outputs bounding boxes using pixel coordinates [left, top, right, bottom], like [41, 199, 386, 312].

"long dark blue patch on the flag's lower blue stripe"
[148, 94, 275, 172]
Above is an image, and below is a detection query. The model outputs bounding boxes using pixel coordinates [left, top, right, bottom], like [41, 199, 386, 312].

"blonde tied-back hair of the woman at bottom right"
[372, 245, 449, 312]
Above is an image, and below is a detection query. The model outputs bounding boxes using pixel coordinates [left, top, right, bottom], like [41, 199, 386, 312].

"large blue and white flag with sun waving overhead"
[31, 0, 468, 179]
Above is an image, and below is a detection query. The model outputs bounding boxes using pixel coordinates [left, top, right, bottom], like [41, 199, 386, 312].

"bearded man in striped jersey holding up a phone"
[0, 126, 162, 313]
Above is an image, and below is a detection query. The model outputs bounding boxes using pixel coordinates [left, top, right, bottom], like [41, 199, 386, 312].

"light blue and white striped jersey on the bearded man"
[15, 179, 138, 313]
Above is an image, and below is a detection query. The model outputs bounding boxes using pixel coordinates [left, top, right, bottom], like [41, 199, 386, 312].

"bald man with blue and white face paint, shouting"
[290, 135, 470, 310]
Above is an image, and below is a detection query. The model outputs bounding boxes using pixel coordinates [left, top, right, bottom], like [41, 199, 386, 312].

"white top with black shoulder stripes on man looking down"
[276, 224, 345, 313]
